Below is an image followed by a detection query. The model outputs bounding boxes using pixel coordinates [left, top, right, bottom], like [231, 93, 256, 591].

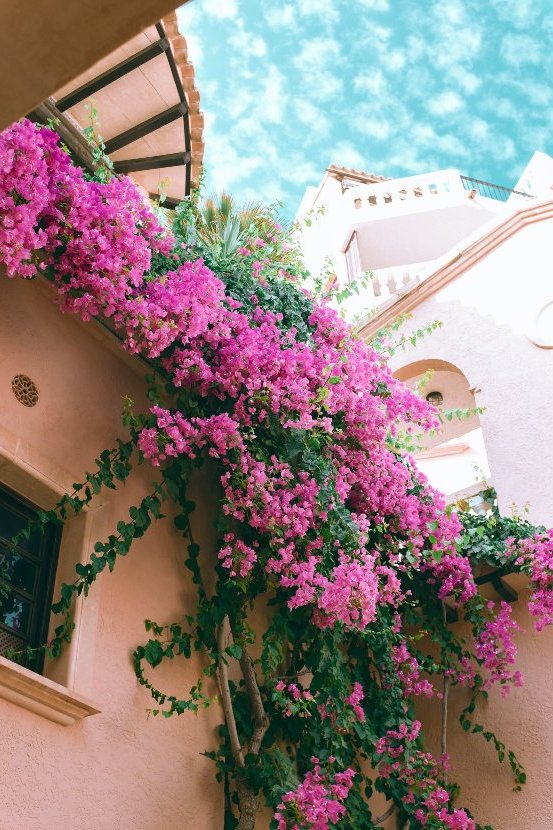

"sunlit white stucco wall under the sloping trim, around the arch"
[386, 214, 553, 525]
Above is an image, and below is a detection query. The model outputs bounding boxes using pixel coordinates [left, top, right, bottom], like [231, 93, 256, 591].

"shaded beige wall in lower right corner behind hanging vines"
[418, 578, 553, 830]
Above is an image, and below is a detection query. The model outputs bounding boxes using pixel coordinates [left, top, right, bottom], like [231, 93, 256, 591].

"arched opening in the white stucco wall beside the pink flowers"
[394, 359, 491, 501]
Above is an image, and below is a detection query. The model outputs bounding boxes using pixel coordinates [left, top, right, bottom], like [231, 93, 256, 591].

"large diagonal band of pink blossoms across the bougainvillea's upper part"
[0, 122, 473, 630]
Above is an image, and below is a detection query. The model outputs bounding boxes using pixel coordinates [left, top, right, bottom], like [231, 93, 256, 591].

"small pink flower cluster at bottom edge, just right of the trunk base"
[274, 757, 355, 830]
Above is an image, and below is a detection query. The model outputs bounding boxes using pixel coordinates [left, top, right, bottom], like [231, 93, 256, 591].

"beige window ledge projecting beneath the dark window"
[0, 657, 100, 726]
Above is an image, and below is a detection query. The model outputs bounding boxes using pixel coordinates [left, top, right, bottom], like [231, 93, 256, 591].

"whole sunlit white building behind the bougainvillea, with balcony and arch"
[298, 153, 553, 524]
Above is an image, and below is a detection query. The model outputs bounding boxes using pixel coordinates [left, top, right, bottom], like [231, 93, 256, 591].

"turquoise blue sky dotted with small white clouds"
[179, 0, 553, 217]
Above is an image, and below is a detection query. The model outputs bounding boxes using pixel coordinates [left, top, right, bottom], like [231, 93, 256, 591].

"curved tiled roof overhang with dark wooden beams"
[30, 13, 203, 205]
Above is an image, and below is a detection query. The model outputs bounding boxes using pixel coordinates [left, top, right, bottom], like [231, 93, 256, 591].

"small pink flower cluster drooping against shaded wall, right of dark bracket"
[474, 602, 523, 697]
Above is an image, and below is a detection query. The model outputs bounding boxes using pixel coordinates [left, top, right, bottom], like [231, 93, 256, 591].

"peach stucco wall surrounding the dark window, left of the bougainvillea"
[0, 278, 222, 830]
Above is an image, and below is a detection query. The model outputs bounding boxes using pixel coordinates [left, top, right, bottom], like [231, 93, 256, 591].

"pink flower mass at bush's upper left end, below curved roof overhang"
[0, 121, 172, 319]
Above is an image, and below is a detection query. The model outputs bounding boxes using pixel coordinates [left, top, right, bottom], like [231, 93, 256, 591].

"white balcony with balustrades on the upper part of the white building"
[342, 169, 531, 311]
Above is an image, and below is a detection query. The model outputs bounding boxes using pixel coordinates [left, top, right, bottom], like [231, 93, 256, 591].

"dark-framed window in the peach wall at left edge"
[0, 488, 61, 672]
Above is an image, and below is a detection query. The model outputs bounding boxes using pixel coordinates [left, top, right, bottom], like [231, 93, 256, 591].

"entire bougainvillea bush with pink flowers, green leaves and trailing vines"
[0, 121, 553, 830]
